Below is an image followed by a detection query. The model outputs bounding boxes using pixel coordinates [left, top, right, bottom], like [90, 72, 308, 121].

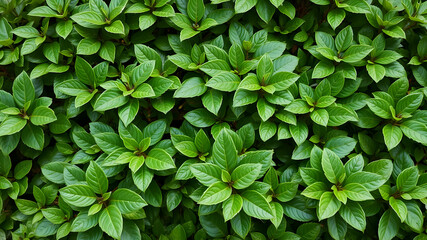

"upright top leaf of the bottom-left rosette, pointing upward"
[86, 161, 108, 194]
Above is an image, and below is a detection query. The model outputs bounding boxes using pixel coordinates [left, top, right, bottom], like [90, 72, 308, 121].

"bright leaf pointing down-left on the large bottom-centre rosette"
[198, 182, 231, 205]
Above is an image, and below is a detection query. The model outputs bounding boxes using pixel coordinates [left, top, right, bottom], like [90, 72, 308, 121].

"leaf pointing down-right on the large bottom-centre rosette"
[241, 190, 274, 219]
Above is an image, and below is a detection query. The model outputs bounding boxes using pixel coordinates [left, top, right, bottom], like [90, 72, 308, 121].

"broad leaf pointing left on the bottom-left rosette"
[59, 184, 96, 207]
